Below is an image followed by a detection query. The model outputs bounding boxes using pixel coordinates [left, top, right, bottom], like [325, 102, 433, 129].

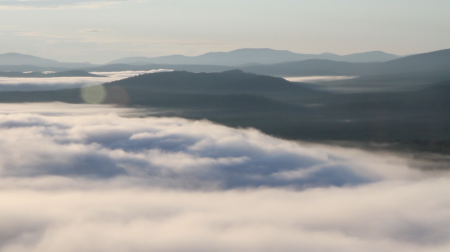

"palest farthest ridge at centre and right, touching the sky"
[108, 48, 401, 66]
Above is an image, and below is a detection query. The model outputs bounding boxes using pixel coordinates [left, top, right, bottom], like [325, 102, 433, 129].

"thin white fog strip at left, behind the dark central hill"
[0, 69, 172, 92]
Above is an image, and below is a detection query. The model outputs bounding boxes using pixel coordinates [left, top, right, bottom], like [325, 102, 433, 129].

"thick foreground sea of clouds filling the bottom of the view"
[0, 103, 450, 252]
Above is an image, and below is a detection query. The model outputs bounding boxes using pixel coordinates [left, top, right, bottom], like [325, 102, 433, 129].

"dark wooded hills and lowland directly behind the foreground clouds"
[0, 71, 450, 148]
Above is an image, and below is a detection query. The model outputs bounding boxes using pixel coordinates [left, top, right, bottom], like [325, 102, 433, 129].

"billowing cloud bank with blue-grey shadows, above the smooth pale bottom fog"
[0, 104, 423, 189]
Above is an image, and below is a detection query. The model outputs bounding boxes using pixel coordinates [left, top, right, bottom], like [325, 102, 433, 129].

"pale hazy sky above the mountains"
[0, 0, 450, 63]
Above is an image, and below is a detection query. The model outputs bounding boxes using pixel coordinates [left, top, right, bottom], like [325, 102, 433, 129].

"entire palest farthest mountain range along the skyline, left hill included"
[0, 49, 400, 71]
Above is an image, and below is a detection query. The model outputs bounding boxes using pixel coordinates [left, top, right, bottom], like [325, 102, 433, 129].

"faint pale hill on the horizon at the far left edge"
[0, 53, 95, 68]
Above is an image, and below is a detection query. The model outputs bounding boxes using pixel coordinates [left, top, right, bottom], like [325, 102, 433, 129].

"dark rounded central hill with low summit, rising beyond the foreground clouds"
[105, 70, 322, 98]
